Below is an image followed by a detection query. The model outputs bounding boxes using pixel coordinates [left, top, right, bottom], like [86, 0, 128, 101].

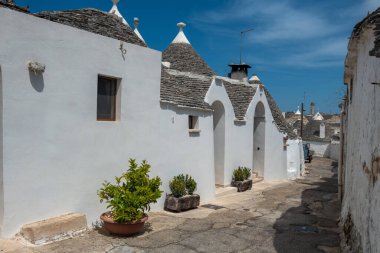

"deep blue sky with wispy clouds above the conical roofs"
[16, 0, 380, 113]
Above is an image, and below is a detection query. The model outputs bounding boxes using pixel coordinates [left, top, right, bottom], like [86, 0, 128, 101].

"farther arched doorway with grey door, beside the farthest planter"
[253, 102, 265, 177]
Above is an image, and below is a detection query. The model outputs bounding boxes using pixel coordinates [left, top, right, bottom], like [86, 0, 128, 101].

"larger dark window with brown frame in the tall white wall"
[97, 76, 118, 121]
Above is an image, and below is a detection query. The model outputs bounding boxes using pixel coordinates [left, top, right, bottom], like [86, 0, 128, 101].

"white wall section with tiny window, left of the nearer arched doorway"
[158, 103, 215, 206]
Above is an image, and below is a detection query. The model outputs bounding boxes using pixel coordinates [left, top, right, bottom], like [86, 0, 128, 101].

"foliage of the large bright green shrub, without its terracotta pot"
[98, 159, 162, 223]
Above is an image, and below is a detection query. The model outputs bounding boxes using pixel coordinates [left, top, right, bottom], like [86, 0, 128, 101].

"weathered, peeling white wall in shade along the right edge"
[339, 8, 380, 253]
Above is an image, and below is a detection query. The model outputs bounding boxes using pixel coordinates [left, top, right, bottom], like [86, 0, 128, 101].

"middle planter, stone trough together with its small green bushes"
[165, 174, 200, 212]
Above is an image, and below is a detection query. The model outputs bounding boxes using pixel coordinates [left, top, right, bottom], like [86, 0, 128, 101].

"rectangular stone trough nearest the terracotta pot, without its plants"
[165, 194, 200, 212]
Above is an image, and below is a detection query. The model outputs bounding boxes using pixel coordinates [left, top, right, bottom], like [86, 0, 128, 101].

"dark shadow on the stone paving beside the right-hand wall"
[273, 159, 341, 253]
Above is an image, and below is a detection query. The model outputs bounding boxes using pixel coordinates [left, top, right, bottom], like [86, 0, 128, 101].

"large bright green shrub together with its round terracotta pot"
[98, 159, 162, 235]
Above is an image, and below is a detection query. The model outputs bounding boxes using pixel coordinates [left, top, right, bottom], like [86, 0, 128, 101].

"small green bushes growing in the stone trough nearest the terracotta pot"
[169, 174, 197, 198]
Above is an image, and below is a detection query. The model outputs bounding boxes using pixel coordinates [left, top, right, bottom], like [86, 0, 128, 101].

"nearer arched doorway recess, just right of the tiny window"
[211, 101, 225, 186]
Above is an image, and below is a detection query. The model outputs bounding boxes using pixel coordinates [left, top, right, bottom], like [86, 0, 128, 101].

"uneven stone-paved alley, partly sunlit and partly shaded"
[3, 158, 340, 253]
